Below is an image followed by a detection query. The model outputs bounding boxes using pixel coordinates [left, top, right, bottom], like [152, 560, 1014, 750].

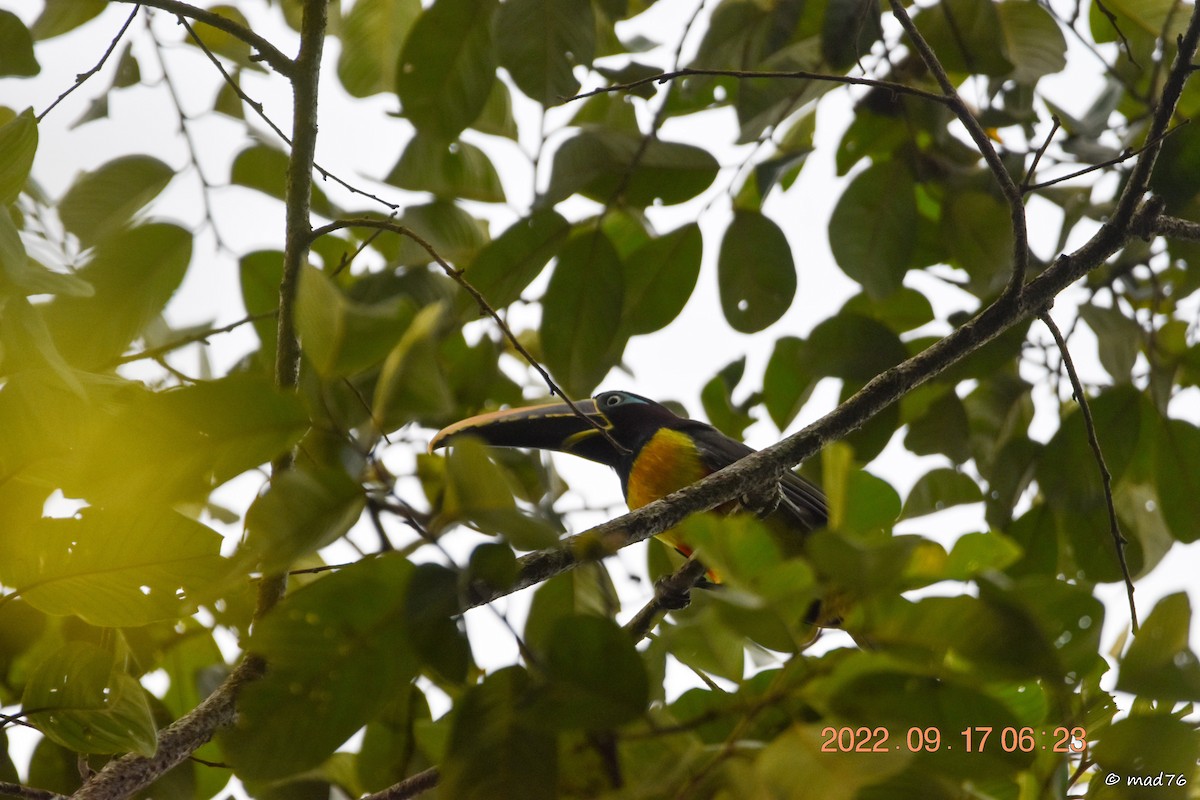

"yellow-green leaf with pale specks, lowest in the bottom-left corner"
[22, 642, 158, 757]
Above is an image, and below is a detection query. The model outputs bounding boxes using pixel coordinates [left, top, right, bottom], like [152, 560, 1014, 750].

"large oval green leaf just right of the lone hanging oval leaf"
[829, 161, 918, 299]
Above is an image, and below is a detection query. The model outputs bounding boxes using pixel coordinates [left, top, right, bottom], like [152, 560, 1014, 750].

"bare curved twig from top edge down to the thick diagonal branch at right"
[889, 0, 1030, 301]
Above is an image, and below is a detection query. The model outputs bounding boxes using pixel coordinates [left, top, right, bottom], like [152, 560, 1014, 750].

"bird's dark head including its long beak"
[430, 392, 685, 468]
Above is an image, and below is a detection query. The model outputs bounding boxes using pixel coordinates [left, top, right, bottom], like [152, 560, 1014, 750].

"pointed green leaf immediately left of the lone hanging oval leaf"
[620, 223, 704, 336]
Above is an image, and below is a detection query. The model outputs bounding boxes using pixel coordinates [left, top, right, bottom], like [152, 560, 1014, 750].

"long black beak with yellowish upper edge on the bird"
[430, 399, 617, 467]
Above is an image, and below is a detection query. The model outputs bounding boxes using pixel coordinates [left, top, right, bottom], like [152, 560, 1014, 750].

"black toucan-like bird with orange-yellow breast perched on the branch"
[430, 391, 838, 626]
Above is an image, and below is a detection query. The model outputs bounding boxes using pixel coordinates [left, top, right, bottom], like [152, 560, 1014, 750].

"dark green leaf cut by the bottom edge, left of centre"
[438, 667, 558, 800]
